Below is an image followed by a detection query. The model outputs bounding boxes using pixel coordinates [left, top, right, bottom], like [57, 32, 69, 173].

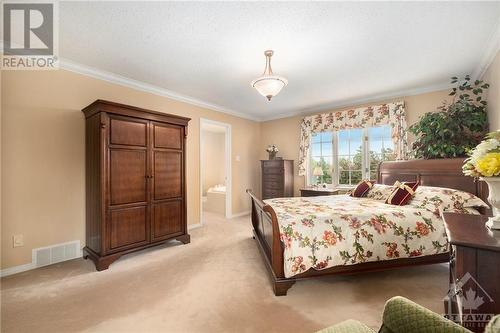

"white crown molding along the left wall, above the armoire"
[59, 58, 261, 122]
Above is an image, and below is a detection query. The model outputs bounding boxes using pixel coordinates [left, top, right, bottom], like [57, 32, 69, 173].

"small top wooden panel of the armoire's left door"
[109, 118, 147, 147]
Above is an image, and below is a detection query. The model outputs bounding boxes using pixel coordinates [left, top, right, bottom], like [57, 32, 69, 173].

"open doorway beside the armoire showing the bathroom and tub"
[200, 118, 232, 224]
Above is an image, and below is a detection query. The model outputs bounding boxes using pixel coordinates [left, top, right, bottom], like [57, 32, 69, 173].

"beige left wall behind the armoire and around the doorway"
[1, 70, 260, 268]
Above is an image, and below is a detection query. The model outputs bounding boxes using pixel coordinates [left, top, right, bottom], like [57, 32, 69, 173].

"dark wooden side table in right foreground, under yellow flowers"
[444, 213, 500, 332]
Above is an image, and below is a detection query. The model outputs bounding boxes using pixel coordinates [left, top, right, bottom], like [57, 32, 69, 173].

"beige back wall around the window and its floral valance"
[260, 90, 450, 195]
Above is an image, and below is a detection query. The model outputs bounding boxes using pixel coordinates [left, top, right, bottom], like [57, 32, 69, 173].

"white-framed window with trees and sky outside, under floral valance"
[309, 125, 395, 186]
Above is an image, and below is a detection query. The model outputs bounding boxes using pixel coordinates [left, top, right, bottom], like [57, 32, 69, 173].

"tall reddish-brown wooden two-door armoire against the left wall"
[82, 100, 190, 271]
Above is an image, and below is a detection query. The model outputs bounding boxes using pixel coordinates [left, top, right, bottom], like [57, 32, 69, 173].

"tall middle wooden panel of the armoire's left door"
[109, 148, 147, 205]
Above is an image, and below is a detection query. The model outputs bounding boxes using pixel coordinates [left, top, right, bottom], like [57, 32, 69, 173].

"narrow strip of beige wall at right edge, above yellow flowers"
[483, 51, 500, 131]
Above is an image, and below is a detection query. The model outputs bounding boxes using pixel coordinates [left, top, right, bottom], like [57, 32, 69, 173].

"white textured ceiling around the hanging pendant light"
[59, 2, 500, 120]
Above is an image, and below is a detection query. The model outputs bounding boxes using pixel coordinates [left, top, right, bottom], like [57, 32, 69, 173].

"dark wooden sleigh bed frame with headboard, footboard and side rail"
[247, 158, 489, 296]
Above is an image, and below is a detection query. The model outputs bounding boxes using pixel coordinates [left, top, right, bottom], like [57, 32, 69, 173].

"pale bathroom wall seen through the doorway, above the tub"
[201, 131, 226, 195]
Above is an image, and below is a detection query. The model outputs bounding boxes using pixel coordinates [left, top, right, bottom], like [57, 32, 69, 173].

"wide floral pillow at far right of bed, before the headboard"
[410, 186, 489, 215]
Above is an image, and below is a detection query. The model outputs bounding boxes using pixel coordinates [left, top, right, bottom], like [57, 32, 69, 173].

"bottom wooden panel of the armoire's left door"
[108, 206, 148, 250]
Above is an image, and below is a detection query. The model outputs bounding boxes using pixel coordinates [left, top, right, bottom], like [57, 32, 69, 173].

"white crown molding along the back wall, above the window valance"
[261, 83, 453, 121]
